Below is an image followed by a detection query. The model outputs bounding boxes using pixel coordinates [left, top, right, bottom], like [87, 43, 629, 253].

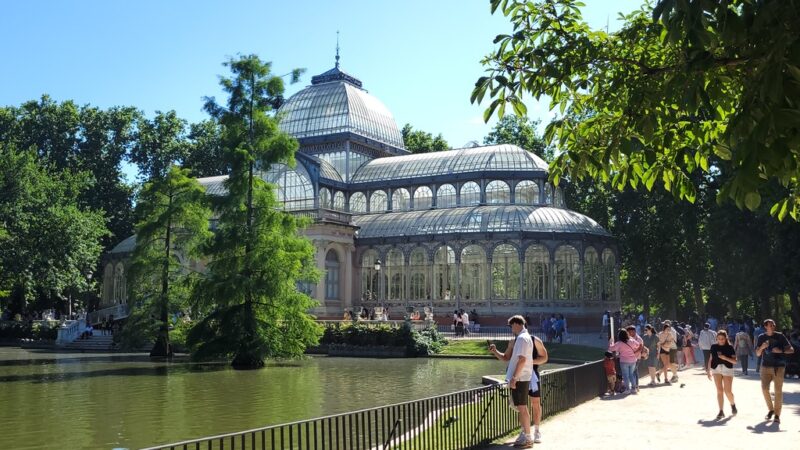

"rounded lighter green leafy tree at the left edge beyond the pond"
[0, 142, 108, 309]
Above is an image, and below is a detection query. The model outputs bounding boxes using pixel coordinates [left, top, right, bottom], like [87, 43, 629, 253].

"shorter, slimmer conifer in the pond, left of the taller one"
[131, 165, 211, 356]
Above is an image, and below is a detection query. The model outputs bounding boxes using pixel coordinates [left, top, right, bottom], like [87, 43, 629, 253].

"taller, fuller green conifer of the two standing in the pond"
[187, 55, 320, 368]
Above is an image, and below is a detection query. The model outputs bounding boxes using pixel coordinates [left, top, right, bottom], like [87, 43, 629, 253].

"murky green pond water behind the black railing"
[0, 347, 564, 449]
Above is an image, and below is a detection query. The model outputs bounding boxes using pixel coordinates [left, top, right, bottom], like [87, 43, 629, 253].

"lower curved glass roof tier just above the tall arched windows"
[353, 205, 610, 239]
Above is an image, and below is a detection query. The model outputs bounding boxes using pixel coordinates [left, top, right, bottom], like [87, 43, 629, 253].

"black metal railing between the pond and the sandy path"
[145, 361, 606, 450]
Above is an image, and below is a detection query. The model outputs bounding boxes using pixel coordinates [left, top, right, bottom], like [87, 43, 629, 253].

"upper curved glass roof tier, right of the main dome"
[352, 144, 547, 183]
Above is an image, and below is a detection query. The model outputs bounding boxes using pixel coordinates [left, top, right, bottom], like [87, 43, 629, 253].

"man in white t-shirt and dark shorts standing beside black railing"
[489, 315, 539, 448]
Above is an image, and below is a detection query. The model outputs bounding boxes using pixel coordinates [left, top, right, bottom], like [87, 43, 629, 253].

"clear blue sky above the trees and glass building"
[0, 0, 641, 151]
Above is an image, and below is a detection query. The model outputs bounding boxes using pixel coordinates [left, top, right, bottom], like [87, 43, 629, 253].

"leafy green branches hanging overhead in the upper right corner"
[471, 0, 800, 220]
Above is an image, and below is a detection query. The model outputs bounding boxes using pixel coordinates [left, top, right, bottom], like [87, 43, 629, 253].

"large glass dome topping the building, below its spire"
[280, 68, 405, 149]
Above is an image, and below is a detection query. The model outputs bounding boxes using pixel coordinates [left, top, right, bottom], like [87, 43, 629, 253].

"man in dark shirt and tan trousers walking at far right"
[756, 319, 794, 424]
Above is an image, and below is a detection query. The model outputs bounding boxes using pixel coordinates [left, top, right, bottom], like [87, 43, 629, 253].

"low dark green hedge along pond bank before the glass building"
[320, 323, 446, 356]
